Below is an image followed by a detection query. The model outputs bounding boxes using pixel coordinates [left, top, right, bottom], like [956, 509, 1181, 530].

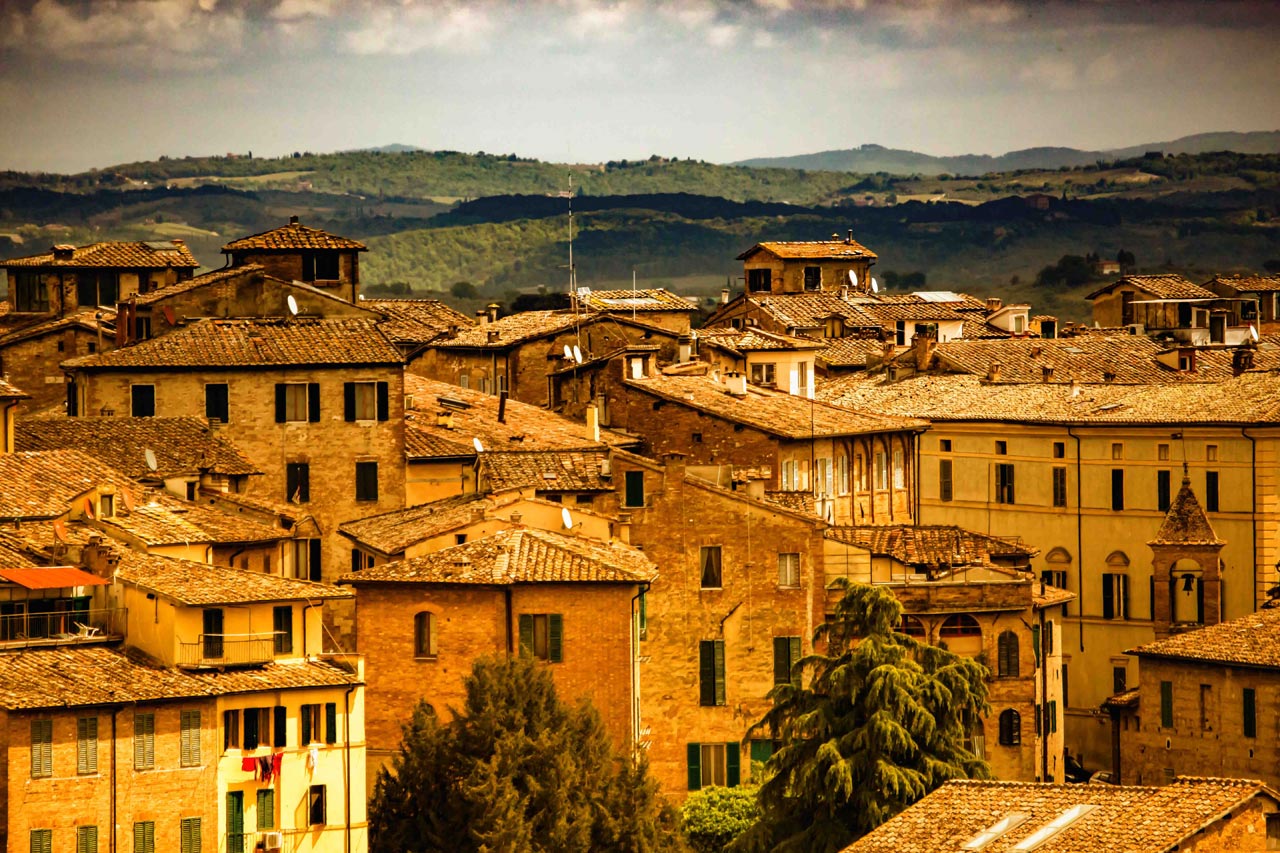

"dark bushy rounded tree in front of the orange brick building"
[369, 656, 682, 853]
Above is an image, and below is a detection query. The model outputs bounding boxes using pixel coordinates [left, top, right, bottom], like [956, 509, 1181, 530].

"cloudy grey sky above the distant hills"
[0, 0, 1280, 170]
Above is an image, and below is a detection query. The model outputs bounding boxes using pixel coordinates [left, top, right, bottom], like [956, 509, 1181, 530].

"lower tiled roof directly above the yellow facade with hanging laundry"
[0, 646, 360, 711]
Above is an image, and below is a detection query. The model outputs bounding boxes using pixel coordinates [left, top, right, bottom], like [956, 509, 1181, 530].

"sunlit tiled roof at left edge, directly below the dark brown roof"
[0, 450, 129, 520]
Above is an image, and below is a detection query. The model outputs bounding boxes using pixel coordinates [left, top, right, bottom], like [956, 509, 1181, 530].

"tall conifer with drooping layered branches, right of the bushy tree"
[730, 583, 988, 853]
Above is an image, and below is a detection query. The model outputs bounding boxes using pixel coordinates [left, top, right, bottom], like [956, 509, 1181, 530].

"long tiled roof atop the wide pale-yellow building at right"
[818, 371, 1280, 425]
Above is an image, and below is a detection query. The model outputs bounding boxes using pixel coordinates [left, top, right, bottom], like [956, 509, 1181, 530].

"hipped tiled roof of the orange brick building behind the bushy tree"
[339, 528, 657, 585]
